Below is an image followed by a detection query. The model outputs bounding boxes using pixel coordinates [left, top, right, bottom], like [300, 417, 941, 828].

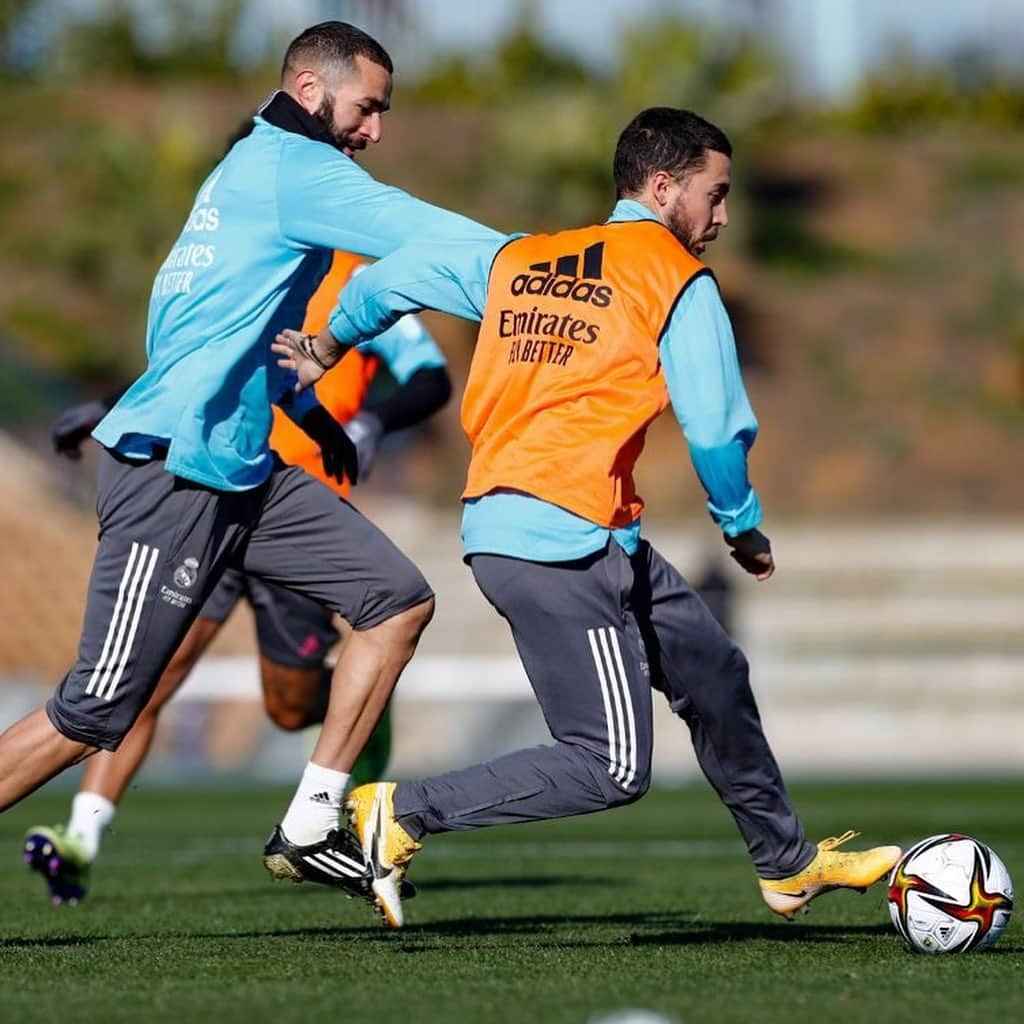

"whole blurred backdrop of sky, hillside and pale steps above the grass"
[0, 0, 1024, 784]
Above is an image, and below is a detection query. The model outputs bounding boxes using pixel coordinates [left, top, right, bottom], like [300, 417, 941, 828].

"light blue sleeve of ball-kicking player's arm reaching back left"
[328, 237, 509, 346]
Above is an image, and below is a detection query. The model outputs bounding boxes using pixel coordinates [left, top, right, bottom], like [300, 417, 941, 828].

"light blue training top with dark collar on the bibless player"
[93, 93, 501, 490]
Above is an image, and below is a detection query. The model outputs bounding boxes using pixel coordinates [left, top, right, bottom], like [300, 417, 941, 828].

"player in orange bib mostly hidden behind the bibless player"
[24, 252, 452, 904]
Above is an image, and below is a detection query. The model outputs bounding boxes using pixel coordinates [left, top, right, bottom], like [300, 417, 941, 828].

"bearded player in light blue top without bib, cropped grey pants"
[0, 22, 497, 895]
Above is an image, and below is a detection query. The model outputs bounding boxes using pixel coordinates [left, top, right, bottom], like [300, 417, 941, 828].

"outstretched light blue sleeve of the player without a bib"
[278, 136, 501, 257]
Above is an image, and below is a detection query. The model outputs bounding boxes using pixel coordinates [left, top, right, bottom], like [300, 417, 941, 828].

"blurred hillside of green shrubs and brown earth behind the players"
[6, 0, 1024, 511]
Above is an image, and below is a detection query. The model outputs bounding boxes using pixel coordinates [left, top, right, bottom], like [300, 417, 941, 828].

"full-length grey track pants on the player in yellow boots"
[395, 542, 815, 878]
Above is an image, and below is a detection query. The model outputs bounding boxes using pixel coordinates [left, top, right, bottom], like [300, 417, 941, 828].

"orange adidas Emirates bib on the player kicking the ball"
[462, 220, 707, 527]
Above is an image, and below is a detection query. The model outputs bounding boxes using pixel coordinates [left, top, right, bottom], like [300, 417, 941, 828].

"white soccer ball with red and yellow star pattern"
[889, 834, 1014, 953]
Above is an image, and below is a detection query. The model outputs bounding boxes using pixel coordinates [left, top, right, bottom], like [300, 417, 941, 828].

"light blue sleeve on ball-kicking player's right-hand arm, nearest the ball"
[658, 274, 761, 537]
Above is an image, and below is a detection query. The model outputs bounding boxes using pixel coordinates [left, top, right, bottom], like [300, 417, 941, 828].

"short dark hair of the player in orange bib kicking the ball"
[612, 106, 732, 199]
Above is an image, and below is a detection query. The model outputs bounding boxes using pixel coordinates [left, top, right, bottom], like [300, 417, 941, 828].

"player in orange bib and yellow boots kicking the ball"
[274, 108, 900, 927]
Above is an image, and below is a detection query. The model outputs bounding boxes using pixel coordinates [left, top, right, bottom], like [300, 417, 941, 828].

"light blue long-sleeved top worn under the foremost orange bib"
[329, 194, 761, 561]
